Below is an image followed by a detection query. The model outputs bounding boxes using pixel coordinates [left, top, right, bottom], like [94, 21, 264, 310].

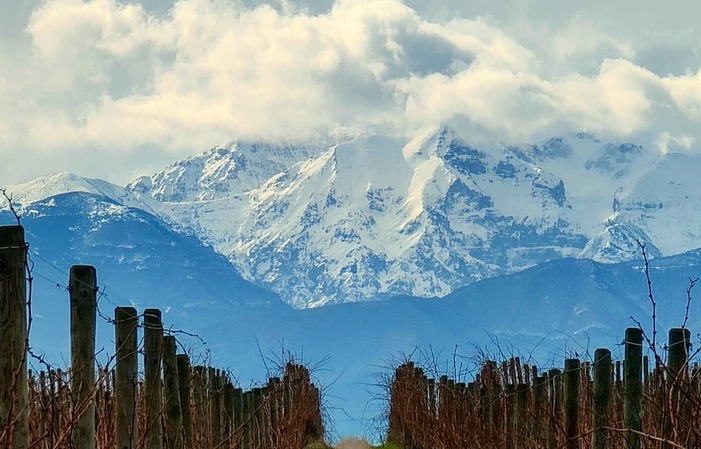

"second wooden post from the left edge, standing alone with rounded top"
[68, 265, 97, 449]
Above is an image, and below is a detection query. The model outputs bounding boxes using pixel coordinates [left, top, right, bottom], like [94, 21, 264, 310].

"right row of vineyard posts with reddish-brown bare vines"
[388, 328, 701, 449]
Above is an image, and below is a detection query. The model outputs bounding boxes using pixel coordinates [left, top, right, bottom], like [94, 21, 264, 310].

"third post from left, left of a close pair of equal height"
[114, 307, 139, 449]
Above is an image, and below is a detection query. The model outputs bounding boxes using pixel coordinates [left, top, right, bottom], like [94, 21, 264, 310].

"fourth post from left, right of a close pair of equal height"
[144, 309, 163, 449]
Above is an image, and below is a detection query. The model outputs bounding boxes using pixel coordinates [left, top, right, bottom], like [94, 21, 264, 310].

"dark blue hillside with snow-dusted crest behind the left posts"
[0, 174, 288, 356]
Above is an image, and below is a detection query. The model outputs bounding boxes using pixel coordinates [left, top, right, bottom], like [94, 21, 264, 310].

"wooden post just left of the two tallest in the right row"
[593, 348, 611, 449]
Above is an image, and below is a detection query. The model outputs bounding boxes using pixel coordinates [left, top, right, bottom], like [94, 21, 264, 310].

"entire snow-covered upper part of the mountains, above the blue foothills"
[5, 127, 701, 308]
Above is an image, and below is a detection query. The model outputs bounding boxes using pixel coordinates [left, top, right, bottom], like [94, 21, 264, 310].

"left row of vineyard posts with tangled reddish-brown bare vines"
[0, 226, 324, 449]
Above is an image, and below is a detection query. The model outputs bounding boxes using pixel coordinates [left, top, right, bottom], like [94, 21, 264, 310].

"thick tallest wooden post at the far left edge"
[0, 226, 29, 449]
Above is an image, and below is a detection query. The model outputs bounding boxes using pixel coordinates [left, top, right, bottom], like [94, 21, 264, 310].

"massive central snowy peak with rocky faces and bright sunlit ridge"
[232, 128, 587, 307]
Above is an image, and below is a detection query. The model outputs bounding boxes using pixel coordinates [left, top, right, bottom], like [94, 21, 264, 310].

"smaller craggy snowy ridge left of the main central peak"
[126, 140, 325, 250]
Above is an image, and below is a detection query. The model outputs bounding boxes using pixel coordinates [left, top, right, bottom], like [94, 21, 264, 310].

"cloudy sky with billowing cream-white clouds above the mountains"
[0, 0, 701, 185]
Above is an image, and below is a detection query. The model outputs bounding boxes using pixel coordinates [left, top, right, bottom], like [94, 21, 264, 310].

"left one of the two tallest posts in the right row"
[623, 327, 643, 449]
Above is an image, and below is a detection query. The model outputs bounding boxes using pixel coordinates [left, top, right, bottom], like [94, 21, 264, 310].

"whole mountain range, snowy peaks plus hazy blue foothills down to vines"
[0, 127, 701, 435]
